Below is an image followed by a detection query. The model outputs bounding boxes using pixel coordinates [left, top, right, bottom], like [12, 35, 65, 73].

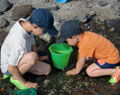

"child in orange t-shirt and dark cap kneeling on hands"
[57, 20, 120, 83]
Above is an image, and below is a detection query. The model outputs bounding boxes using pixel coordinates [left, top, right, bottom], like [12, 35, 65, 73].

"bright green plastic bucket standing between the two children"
[49, 43, 73, 69]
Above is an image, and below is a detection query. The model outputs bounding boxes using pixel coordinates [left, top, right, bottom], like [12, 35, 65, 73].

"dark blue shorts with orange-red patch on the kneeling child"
[95, 59, 120, 68]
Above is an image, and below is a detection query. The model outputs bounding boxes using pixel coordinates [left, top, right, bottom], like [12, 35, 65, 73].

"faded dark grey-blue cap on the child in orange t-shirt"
[56, 20, 83, 43]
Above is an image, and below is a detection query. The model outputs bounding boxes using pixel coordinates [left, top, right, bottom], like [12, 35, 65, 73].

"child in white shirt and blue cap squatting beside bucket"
[1, 9, 57, 89]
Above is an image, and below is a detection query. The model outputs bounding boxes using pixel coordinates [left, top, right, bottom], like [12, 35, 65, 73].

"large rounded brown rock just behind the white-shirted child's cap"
[11, 5, 32, 20]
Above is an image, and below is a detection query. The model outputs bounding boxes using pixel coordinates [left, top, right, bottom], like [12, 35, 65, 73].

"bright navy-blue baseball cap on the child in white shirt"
[30, 8, 58, 36]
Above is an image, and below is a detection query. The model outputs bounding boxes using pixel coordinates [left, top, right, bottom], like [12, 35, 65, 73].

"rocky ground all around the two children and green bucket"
[0, 0, 120, 95]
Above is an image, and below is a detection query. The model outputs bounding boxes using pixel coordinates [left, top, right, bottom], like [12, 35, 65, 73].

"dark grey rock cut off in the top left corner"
[0, 0, 11, 14]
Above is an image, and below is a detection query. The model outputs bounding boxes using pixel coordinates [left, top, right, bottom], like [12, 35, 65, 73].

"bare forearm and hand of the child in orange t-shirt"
[66, 57, 85, 75]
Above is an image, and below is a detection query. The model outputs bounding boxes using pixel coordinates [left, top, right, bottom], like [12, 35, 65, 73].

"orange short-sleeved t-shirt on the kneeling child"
[77, 31, 120, 64]
